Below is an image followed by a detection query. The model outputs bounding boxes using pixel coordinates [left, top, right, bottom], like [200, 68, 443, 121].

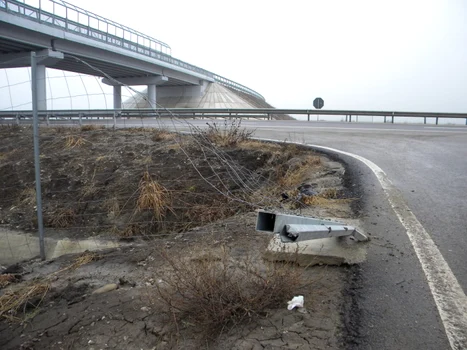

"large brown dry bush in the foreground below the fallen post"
[157, 248, 303, 341]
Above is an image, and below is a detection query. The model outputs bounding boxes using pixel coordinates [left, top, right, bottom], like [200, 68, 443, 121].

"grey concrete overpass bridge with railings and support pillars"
[0, 0, 264, 110]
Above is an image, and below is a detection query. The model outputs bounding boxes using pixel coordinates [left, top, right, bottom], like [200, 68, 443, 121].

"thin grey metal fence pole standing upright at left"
[31, 52, 45, 260]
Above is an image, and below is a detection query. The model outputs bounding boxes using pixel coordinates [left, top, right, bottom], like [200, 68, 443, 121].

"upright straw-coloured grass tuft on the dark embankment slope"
[136, 171, 172, 221]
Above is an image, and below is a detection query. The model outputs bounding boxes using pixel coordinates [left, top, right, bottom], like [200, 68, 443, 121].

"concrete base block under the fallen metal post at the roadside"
[264, 235, 368, 266]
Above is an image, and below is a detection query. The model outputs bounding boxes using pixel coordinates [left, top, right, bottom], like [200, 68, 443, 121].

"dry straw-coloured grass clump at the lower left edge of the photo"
[0, 282, 50, 321]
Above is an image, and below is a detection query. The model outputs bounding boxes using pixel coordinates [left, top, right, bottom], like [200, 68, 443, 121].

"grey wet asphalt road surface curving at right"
[163, 121, 467, 350]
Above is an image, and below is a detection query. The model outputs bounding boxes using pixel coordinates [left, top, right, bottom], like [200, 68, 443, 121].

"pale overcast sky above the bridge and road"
[2, 0, 467, 112]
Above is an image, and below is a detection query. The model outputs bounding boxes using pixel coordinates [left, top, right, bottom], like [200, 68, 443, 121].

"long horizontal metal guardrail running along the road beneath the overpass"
[0, 108, 467, 125]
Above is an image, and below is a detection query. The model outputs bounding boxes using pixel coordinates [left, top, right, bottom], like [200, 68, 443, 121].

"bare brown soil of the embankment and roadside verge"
[0, 127, 360, 350]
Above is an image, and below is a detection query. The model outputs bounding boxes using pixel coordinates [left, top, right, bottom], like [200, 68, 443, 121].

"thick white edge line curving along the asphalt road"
[262, 139, 467, 350]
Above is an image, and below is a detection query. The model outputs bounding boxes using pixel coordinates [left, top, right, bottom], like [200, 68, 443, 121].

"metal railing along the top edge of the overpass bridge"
[0, 0, 264, 100]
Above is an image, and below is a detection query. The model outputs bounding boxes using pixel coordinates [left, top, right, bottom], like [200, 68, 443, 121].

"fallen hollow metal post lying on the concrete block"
[256, 210, 368, 243]
